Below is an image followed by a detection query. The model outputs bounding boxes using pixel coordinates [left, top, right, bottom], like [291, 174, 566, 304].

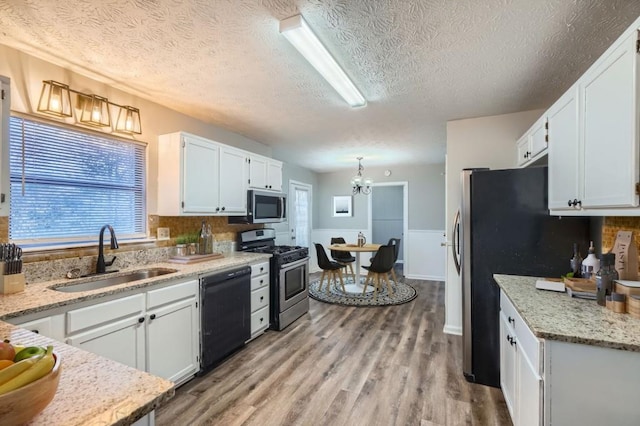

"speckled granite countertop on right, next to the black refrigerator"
[493, 274, 640, 352]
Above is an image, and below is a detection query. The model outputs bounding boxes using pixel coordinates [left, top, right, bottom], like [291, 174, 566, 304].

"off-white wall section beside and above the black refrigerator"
[444, 110, 544, 334]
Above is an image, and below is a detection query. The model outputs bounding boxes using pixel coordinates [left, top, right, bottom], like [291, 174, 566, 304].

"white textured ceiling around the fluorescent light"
[0, 0, 640, 171]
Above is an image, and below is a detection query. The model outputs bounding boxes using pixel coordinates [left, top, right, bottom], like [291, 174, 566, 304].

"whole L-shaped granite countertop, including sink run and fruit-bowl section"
[0, 252, 271, 425]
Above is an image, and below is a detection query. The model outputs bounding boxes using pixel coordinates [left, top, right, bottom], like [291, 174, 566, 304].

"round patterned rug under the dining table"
[309, 277, 417, 306]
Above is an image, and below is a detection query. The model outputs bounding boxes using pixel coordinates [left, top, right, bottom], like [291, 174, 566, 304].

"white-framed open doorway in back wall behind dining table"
[369, 182, 409, 264]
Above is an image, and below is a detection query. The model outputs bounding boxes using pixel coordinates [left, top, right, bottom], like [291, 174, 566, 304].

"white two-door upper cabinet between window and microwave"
[158, 132, 249, 216]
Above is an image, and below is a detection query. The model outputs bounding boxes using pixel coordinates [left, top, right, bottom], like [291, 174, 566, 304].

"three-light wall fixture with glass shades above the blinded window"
[38, 80, 142, 134]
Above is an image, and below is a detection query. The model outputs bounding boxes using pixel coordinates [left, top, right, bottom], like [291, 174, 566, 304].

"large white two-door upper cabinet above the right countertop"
[545, 19, 640, 216]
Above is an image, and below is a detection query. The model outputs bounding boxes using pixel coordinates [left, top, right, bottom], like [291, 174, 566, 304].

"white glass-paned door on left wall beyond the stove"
[289, 180, 312, 247]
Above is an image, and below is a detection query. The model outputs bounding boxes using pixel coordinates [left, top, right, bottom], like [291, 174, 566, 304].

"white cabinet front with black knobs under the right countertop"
[500, 293, 543, 426]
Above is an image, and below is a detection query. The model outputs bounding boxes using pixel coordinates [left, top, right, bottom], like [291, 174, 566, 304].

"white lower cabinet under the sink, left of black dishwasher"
[66, 280, 200, 384]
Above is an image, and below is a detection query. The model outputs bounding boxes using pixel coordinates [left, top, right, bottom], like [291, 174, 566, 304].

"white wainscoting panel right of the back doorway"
[404, 229, 446, 281]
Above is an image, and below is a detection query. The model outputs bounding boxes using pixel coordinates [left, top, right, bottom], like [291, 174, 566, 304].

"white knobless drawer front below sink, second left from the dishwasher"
[67, 294, 144, 334]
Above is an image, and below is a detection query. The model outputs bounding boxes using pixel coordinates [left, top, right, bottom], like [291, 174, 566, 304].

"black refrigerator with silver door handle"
[453, 167, 590, 387]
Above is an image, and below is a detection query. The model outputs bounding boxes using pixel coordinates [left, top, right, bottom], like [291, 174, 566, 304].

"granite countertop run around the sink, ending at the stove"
[0, 252, 271, 320]
